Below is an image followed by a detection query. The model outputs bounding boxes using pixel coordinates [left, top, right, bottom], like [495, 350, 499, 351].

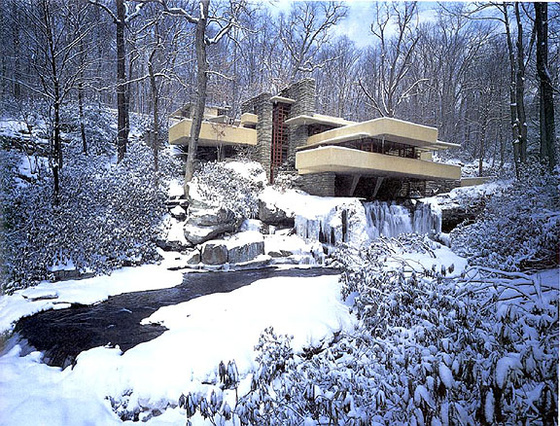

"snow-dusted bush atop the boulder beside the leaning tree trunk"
[193, 162, 263, 219]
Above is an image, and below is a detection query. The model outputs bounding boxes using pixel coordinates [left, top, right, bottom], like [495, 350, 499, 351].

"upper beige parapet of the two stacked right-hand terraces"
[305, 117, 458, 149]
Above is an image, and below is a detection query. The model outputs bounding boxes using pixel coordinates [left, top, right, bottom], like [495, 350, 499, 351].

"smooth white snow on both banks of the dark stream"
[0, 266, 354, 425]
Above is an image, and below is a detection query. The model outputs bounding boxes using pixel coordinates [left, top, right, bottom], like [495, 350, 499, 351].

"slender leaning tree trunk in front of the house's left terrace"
[184, 0, 210, 196]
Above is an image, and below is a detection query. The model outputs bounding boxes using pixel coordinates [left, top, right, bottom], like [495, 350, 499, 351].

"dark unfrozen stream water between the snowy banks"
[15, 268, 338, 367]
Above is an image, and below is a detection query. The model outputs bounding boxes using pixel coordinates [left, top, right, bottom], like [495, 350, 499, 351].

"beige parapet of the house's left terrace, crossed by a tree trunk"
[169, 119, 257, 146]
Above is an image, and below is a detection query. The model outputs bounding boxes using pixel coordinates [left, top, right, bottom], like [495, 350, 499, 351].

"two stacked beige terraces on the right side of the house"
[294, 117, 461, 180]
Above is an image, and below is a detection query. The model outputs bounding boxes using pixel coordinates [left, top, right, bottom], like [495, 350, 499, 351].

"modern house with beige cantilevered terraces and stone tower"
[169, 79, 461, 199]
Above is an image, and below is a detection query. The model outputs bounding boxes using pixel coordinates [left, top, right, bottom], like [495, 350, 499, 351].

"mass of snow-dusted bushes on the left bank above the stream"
[0, 141, 165, 291]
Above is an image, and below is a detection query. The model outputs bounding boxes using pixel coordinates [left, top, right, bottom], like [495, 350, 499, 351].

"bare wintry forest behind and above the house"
[0, 0, 560, 185]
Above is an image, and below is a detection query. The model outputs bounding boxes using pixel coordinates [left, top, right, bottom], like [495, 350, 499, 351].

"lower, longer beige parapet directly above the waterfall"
[296, 146, 461, 180]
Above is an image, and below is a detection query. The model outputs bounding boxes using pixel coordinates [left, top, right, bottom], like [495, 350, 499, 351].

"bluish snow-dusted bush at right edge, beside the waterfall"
[451, 165, 560, 271]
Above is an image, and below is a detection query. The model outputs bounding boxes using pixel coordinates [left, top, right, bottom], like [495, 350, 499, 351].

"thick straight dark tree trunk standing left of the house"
[116, 0, 128, 162]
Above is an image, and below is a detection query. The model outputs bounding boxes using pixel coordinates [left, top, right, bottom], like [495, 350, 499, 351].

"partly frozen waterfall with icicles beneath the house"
[295, 200, 441, 245]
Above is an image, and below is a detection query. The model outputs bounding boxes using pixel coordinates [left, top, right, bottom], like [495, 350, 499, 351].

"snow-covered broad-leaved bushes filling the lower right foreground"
[178, 236, 558, 425]
